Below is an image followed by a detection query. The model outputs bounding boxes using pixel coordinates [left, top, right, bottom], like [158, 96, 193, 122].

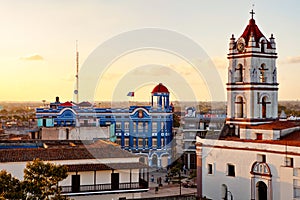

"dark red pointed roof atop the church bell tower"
[241, 19, 272, 48]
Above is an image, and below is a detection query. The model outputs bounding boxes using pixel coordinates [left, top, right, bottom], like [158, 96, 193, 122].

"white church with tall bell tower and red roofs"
[196, 10, 300, 200]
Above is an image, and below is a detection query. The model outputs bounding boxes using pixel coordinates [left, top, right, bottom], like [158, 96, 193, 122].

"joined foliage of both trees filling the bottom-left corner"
[0, 159, 68, 200]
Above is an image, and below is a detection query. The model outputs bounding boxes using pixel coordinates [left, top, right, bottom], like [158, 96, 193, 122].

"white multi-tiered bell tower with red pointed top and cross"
[226, 10, 278, 125]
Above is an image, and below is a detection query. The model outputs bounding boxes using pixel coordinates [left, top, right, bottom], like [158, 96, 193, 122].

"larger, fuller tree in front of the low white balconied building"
[24, 159, 68, 200]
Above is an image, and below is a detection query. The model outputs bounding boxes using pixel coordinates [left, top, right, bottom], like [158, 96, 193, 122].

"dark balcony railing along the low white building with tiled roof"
[61, 182, 148, 193]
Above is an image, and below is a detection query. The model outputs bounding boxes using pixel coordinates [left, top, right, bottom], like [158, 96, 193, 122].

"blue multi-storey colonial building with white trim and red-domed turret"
[36, 83, 173, 167]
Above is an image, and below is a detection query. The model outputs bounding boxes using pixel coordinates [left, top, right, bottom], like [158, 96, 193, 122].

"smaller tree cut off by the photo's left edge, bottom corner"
[0, 170, 23, 200]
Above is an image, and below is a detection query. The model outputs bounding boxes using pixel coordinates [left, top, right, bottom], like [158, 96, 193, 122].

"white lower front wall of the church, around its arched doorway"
[197, 138, 300, 200]
